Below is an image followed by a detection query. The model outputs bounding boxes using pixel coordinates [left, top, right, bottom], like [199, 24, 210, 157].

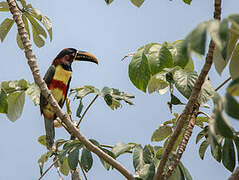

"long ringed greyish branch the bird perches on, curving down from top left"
[7, 0, 134, 180]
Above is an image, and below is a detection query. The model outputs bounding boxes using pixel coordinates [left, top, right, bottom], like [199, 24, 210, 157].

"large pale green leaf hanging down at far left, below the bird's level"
[7, 91, 25, 122]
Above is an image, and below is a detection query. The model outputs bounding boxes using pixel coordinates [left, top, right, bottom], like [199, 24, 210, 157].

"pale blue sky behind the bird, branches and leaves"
[0, 0, 239, 180]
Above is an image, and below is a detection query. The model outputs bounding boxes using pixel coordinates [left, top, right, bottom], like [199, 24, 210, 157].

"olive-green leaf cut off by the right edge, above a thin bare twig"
[229, 43, 239, 80]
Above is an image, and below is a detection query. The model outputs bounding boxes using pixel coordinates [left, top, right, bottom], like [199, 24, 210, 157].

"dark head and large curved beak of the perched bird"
[52, 48, 98, 66]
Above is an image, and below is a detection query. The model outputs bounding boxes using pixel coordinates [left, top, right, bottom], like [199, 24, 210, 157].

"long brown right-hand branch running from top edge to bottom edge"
[154, 0, 221, 180]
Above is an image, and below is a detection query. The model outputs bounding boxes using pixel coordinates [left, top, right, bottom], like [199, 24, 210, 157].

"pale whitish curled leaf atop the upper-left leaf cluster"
[30, 8, 52, 41]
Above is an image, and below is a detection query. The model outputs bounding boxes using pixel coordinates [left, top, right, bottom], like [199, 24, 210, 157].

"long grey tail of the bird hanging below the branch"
[44, 118, 55, 149]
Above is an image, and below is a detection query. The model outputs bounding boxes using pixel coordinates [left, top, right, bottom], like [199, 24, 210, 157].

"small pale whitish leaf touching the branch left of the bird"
[26, 83, 41, 105]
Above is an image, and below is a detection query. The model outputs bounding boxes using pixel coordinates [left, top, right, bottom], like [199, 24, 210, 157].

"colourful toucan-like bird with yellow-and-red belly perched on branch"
[40, 48, 98, 150]
